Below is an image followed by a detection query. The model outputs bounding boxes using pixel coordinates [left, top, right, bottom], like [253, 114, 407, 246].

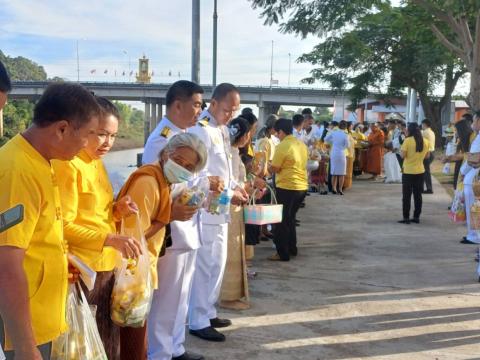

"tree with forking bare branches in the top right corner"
[410, 0, 480, 110]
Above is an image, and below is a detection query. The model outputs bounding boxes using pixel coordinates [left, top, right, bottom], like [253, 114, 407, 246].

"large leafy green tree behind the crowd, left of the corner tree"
[252, 0, 466, 143]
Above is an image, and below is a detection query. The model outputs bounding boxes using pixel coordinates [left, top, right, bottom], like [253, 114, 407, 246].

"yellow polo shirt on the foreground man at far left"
[0, 135, 68, 350]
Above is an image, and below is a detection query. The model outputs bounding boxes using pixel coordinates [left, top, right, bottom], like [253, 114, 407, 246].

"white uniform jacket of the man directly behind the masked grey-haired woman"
[142, 116, 201, 250]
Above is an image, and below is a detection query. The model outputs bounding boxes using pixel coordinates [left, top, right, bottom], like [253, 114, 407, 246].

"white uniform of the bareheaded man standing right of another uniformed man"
[188, 110, 236, 330]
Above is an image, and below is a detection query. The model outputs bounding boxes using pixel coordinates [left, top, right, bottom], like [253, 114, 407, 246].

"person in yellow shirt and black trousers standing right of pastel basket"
[269, 119, 308, 261]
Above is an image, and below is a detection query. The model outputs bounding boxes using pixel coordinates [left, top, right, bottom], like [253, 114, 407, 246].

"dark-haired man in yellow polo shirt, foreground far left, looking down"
[0, 83, 100, 360]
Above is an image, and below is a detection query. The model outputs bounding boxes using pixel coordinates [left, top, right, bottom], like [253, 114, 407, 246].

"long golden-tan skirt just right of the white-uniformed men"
[220, 205, 249, 301]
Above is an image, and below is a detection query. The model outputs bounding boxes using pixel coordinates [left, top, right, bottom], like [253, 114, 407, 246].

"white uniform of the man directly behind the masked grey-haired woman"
[143, 117, 200, 360]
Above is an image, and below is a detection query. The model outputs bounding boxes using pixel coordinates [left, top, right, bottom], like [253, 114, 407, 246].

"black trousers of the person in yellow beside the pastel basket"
[273, 188, 306, 261]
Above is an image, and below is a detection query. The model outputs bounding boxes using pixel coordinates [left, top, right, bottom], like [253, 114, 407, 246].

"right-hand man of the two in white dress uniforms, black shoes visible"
[188, 83, 247, 342]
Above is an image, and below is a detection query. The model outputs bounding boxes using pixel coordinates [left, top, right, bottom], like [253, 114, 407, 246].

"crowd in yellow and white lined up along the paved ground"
[0, 51, 468, 360]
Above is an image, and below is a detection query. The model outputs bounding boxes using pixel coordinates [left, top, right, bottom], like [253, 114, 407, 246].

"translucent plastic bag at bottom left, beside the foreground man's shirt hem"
[50, 283, 107, 360]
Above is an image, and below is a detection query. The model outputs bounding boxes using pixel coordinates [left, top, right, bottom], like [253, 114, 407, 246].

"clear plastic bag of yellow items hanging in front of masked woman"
[111, 214, 153, 327]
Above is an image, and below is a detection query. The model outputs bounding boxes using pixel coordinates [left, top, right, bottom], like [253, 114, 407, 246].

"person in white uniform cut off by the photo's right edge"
[460, 114, 480, 244]
